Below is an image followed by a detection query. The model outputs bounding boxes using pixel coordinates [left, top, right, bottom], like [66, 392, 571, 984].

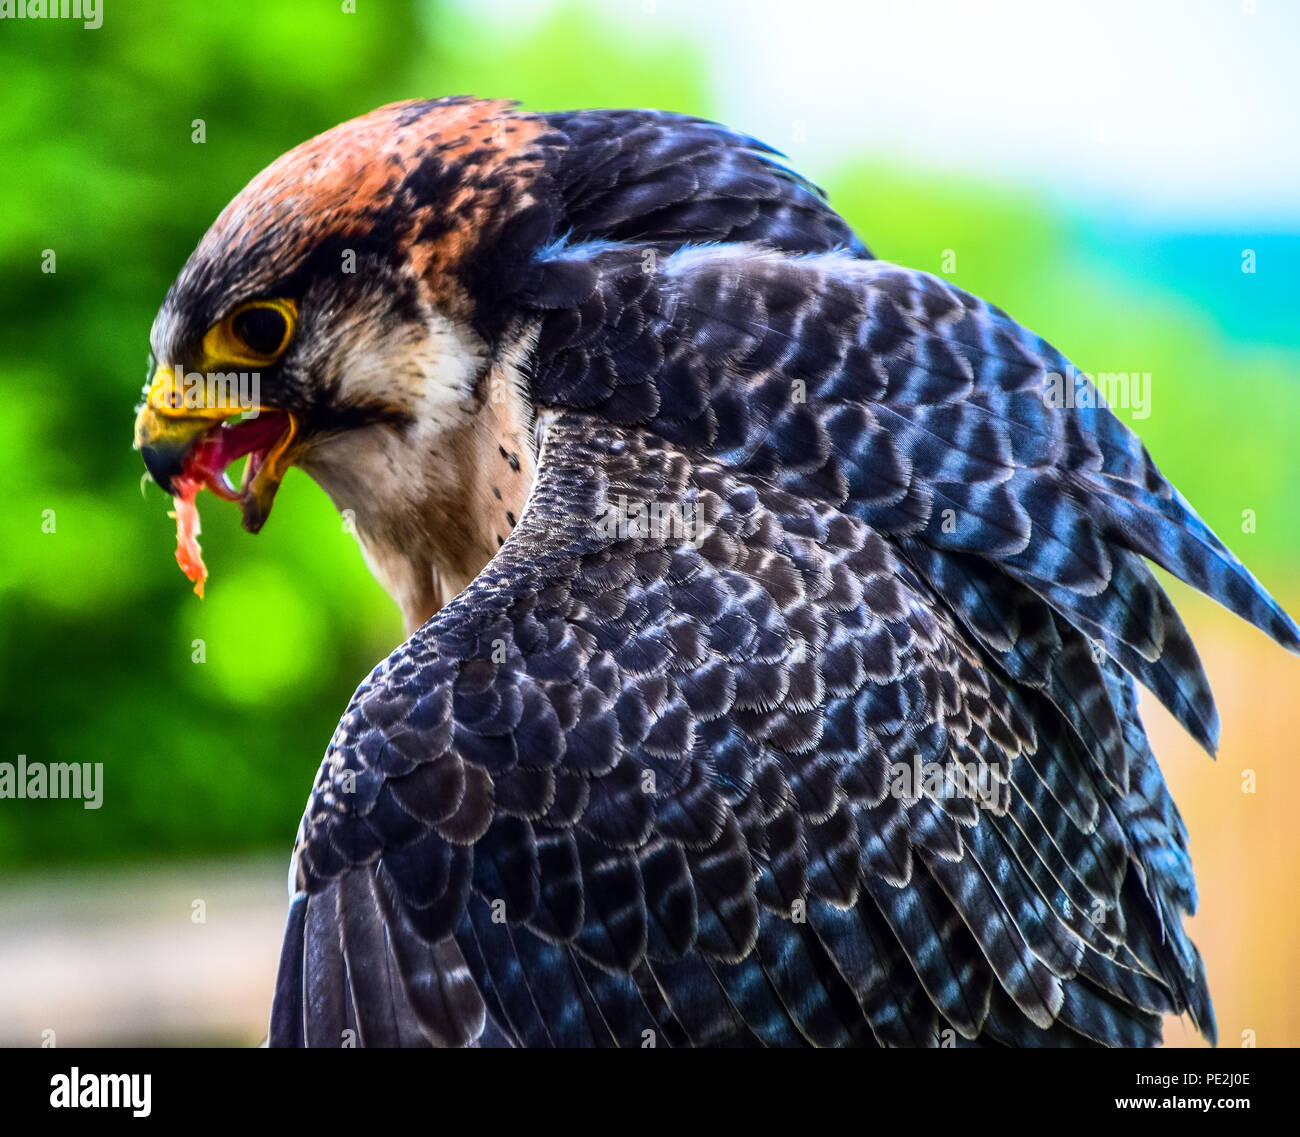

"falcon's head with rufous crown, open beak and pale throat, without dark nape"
[135, 100, 551, 621]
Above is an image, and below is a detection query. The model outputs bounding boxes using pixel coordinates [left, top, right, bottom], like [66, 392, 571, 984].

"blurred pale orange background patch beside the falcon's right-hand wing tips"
[1141, 583, 1300, 1047]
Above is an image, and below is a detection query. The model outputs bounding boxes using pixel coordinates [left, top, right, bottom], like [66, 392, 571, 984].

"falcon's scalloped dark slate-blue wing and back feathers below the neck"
[270, 233, 1300, 1046]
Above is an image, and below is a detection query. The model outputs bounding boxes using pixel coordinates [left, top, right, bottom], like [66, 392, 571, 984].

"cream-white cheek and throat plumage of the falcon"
[300, 317, 536, 628]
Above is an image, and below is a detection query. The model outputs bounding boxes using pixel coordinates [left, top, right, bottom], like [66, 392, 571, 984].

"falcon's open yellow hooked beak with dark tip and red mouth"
[135, 365, 300, 533]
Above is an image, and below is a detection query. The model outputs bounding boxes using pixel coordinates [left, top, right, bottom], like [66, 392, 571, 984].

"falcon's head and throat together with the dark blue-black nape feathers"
[135, 99, 861, 628]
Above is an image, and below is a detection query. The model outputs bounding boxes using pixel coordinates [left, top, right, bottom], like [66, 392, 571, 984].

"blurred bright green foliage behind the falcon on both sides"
[0, 3, 1300, 868]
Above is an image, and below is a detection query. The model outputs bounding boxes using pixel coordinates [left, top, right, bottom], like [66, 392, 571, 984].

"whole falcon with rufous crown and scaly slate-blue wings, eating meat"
[137, 99, 1300, 1046]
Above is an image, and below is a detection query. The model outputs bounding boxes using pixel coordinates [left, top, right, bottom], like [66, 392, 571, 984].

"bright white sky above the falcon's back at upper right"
[460, 0, 1300, 226]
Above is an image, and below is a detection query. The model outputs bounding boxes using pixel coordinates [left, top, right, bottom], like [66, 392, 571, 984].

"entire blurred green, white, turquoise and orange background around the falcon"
[0, 0, 1300, 1046]
